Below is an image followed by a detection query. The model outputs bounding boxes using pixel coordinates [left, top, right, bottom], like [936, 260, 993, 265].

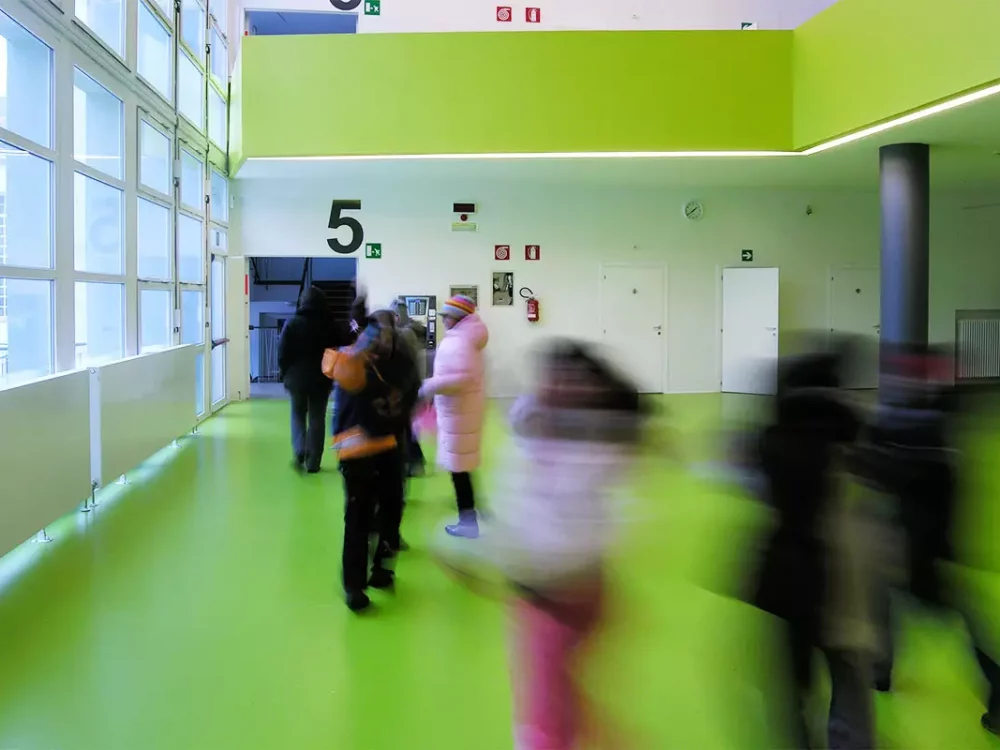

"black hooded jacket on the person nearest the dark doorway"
[278, 287, 344, 390]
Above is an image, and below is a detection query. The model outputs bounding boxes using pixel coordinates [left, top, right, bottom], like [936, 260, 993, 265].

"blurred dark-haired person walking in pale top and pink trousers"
[439, 342, 647, 750]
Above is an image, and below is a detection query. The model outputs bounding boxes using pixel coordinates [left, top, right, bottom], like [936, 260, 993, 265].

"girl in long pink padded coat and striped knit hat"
[421, 295, 489, 539]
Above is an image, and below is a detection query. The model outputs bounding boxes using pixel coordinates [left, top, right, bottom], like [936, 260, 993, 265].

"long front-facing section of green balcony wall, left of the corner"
[241, 32, 792, 157]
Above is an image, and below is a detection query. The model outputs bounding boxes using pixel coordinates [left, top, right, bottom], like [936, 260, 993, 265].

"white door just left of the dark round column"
[830, 268, 882, 388]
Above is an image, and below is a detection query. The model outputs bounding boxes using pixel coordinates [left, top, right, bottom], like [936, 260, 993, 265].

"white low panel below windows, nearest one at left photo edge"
[0, 370, 91, 556]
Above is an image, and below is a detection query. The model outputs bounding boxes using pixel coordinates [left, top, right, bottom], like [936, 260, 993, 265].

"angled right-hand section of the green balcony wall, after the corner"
[792, 0, 1000, 149]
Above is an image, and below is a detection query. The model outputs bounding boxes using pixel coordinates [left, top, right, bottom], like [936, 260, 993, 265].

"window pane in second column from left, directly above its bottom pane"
[73, 172, 125, 275]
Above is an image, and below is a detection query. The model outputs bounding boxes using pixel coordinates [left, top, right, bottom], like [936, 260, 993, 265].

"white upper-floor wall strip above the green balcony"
[230, 0, 836, 62]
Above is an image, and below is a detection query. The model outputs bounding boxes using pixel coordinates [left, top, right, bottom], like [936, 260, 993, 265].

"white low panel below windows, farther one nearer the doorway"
[90, 346, 198, 487]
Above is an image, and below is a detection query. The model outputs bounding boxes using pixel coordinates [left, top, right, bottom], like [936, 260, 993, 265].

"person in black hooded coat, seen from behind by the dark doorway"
[278, 287, 347, 474]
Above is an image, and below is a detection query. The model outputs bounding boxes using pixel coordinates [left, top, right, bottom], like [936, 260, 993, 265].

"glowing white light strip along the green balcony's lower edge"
[247, 84, 1000, 162]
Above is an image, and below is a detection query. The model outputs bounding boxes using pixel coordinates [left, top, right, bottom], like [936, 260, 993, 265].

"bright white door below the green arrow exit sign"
[722, 268, 778, 395]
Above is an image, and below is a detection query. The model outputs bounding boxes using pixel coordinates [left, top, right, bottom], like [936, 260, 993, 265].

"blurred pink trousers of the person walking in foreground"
[513, 584, 602, 750]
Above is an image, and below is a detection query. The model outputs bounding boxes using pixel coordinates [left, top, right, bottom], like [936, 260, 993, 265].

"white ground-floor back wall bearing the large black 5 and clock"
[236, 180, 1000, 395]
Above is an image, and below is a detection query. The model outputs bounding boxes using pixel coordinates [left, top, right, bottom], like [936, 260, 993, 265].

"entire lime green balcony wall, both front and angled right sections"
[230, 0, 1000, 167]
